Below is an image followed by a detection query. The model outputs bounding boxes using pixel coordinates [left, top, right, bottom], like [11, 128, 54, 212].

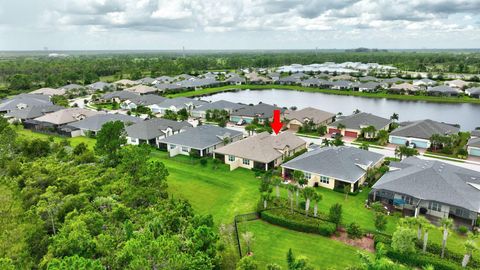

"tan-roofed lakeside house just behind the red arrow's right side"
[284, 107, 335, 131]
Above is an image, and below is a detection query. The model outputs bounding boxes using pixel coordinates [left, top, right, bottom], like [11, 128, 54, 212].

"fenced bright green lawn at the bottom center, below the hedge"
[239, 220, 366, 269]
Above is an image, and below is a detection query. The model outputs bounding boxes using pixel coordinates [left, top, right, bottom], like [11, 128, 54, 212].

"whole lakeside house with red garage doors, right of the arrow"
[327, 112, 392, 138]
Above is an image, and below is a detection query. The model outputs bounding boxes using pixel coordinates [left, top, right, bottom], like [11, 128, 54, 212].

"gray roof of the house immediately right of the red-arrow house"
[282, 146, 383, 183]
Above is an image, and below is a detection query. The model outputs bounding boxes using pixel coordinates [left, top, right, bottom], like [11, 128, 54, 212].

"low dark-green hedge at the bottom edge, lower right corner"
[386, 249, 465, 270]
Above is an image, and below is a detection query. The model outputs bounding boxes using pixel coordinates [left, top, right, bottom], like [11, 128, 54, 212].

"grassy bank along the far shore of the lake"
[168, 84, 480, 104]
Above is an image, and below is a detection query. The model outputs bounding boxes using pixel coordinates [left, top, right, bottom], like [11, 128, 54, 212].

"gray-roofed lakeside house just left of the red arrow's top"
[230, 103, 285, 124]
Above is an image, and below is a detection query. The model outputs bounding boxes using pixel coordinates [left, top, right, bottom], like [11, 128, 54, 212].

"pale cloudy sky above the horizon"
[0, 0, 480, 51]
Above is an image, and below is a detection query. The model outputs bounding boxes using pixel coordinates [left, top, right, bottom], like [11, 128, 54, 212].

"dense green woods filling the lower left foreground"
[0, 121, 220, 269]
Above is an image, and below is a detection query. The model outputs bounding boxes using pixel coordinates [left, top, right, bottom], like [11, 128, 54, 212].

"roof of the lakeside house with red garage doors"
[330, 112, 392, 130]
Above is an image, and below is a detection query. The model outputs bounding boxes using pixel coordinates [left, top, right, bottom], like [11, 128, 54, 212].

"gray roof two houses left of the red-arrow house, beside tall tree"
[125, 118, 192, 140]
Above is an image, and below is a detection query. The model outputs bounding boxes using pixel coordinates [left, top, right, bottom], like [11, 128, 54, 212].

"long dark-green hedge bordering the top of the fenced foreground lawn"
[260, 208, 336, 237]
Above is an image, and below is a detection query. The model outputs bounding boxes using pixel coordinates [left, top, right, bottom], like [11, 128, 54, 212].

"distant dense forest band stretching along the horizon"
[0, 51, 480, 95]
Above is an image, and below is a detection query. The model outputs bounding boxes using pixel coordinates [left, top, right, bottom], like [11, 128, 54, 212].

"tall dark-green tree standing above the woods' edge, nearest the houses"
[95, 121, 127, 166]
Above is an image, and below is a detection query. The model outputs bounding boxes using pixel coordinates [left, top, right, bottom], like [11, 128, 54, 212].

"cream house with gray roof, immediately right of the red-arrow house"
[282, 146, 384, 192]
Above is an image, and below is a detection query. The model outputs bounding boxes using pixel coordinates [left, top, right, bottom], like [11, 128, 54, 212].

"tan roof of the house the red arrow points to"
[214, 132, 306, 163]
